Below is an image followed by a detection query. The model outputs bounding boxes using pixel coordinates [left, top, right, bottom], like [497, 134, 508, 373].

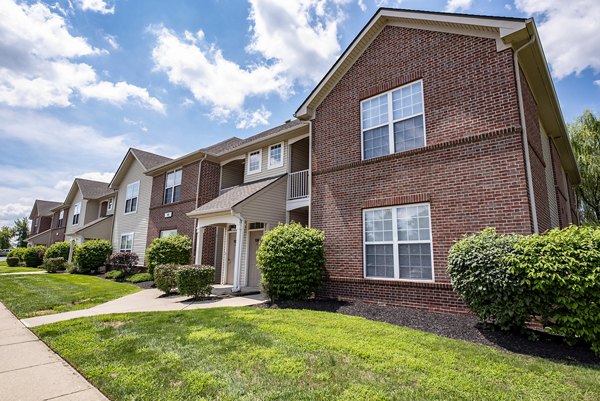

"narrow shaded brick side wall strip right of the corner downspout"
[520, 71, 552, 232]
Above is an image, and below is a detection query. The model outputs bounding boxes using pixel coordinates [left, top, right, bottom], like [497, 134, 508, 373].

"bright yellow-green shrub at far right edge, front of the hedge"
[507, 226, 600, 354]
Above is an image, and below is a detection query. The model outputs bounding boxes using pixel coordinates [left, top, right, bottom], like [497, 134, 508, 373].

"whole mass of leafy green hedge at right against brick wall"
[448, 226, 600, 355]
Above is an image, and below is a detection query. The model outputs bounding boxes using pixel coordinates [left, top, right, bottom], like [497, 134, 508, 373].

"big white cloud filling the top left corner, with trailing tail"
[0, 0, 164, 112]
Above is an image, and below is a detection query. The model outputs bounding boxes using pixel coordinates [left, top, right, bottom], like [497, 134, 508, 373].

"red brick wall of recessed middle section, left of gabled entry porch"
[147, 160, 220, 265]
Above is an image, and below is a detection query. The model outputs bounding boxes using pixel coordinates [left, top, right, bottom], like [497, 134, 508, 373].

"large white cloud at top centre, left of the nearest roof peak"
[152, 0, 349, 127]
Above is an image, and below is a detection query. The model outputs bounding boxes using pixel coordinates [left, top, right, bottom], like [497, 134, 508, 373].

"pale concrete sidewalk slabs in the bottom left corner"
[0, 303, 108, 401]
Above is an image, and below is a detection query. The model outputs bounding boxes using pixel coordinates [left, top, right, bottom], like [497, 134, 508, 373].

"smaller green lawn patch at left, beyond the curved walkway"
[0, 274, 139, 319]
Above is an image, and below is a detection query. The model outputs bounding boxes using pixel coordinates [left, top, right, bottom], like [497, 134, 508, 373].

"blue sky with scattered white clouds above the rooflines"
[0, 0, 600, 225]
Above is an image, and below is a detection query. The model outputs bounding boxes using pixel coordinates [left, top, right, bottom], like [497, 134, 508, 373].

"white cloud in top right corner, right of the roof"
[515, 0, 600, 79]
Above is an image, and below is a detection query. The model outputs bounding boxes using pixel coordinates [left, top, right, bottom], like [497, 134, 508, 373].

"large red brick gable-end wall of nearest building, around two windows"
[311, 27, 532, 312]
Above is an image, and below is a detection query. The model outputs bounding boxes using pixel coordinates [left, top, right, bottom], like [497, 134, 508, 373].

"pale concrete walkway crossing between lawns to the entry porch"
[22, 288, 265, 327]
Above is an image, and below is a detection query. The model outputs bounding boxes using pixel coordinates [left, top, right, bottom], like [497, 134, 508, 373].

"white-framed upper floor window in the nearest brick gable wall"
[360, 81, 425, 160]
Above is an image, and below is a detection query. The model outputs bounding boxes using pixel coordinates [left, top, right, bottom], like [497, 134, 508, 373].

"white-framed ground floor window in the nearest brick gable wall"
[363, 203, 433, 280]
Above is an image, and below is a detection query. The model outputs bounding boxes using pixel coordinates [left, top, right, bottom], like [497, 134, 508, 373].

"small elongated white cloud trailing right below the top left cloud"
[79, 81, 165, 113]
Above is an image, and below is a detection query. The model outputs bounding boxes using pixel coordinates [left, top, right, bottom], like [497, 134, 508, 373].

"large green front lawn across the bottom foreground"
[34, 308, 600, 401]
